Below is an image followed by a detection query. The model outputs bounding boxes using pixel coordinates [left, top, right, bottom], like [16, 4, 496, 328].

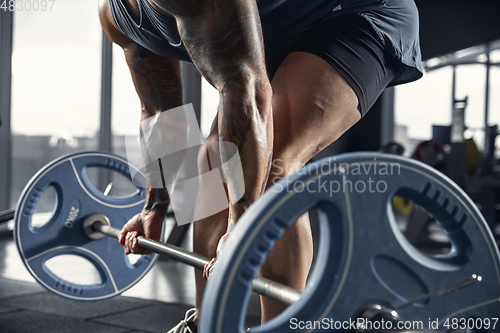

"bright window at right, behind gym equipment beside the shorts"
[395, 43, 500, 155]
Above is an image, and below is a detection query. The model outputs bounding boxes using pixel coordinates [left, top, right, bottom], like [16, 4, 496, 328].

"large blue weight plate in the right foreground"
[200, 153, 500, 332]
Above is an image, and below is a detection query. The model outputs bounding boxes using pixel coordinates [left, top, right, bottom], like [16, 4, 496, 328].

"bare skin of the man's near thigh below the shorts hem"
[268, 52, 361, 186]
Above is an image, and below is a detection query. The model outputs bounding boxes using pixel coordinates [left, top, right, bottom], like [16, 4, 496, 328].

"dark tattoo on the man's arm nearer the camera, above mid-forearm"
[157, 0, 267, 150]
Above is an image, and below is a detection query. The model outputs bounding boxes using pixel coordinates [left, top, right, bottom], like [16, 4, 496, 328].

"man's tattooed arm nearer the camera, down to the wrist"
[155, 0, 273, 222]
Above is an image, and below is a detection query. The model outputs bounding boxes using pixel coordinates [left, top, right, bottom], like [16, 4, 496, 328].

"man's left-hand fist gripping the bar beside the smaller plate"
[118, 210, 164, 254]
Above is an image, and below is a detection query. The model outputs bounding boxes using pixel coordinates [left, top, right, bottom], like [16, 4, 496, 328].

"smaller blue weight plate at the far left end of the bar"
[14, 151, 157, 300]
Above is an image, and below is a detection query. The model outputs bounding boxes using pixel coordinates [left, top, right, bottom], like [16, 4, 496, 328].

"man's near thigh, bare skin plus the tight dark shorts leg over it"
[268, 15, 405, 185]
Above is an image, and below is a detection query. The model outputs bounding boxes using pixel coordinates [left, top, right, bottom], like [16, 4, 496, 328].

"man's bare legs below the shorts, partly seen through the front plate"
[194, 52, 360, 322]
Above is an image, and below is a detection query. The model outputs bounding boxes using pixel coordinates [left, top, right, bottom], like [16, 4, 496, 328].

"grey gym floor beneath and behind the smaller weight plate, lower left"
[0, 217, 260, 333]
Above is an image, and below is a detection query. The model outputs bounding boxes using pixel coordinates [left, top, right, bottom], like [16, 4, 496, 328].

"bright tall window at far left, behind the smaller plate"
[10, 0, 102, 206]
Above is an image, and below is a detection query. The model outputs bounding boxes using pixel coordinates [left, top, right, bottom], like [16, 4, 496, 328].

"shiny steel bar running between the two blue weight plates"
[84, 214, 300, 305]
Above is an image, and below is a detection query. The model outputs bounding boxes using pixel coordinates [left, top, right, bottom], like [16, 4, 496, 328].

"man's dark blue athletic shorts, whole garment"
[260, 0, 422, 116]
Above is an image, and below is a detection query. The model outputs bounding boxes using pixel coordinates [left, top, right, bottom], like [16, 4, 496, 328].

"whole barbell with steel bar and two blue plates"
[14, 152, 500, 333]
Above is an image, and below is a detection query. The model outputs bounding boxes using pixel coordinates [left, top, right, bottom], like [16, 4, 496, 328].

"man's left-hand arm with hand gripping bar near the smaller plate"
[99, 1, 182, 253]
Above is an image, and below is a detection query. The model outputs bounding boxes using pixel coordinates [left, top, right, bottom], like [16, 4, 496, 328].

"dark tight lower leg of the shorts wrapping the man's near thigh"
[290, 14, 406, 116]
